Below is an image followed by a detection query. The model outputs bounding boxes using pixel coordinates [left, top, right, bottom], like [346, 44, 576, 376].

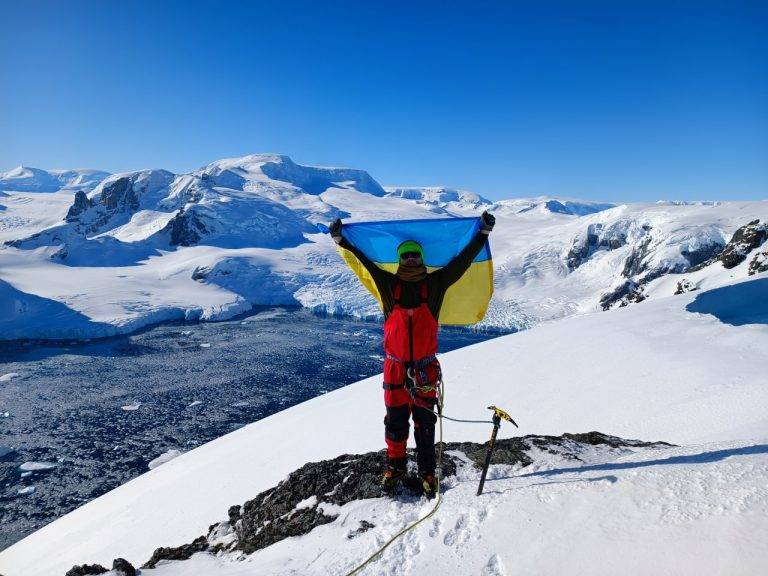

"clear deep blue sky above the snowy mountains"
[0, 0, 768, 201]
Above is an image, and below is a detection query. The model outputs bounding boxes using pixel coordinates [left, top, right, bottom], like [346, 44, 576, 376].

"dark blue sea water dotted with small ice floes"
[0, 308, 494, 550]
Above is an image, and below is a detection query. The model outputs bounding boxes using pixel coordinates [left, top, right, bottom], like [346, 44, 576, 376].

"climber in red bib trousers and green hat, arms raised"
[330, 212, 496, 497]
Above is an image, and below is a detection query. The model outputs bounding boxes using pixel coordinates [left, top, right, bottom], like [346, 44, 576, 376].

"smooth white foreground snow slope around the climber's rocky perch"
[0, 275, 768, 576]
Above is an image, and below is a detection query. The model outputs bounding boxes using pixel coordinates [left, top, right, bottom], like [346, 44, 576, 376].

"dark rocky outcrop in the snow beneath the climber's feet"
[121, 432, 670, 568]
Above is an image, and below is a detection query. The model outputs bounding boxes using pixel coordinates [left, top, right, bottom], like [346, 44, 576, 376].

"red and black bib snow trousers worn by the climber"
[384, 282, 440, 474]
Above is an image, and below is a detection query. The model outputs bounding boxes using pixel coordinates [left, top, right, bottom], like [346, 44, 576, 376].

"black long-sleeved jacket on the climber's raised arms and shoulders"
[339, 232, 488, 320]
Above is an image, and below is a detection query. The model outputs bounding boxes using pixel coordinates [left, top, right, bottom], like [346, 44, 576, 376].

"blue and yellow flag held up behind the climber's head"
[330, 218, 493, 326]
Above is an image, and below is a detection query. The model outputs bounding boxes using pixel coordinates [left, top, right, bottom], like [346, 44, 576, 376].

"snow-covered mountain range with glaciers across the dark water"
[0, 154, 768, 339]
